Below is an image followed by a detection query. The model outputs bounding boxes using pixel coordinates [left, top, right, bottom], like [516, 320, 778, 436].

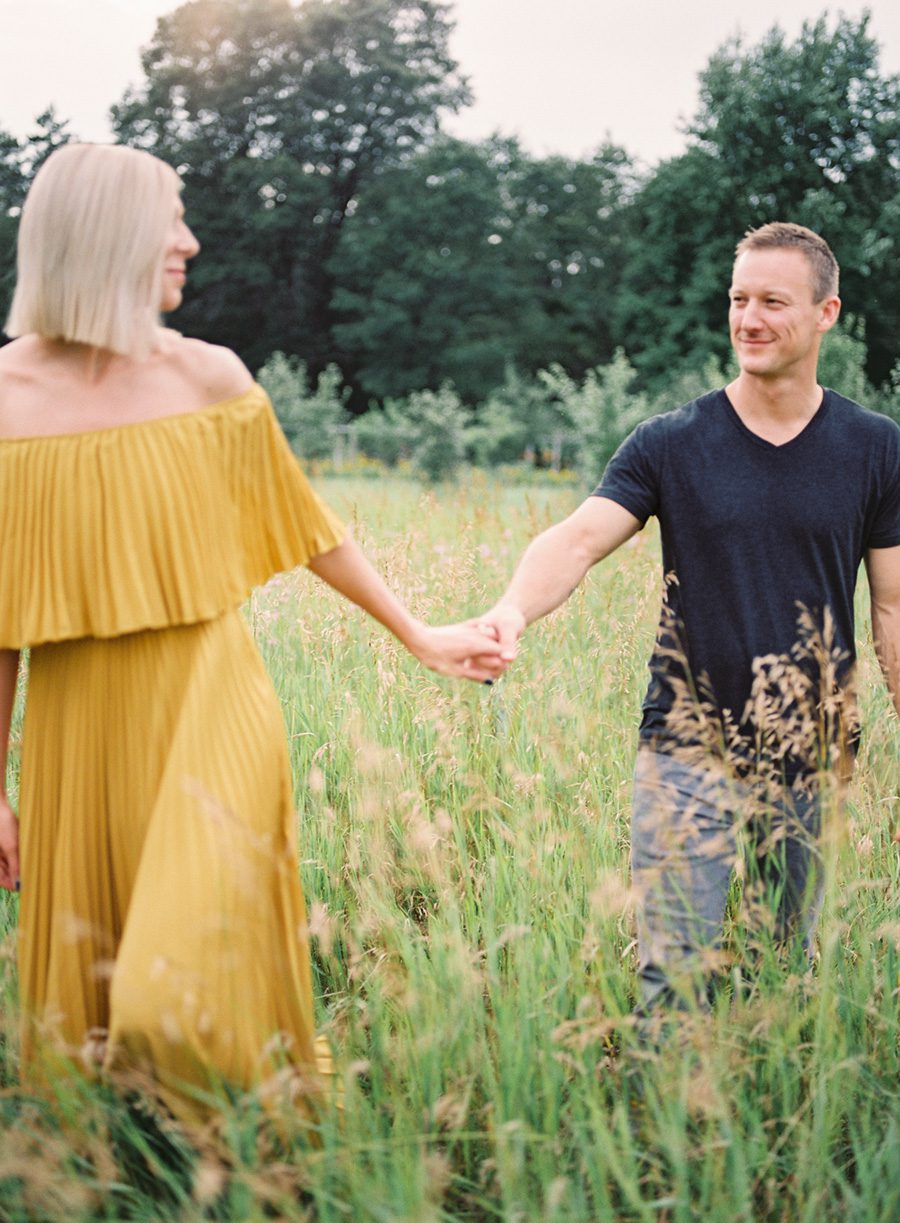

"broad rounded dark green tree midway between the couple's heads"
[331, 138, 631, 402]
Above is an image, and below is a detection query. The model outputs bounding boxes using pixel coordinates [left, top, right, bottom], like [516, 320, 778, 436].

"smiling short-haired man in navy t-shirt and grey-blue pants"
[481, 223, 900, 1009]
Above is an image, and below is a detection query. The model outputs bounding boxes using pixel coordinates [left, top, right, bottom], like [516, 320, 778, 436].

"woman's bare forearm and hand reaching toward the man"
[308, 537, 504, 680]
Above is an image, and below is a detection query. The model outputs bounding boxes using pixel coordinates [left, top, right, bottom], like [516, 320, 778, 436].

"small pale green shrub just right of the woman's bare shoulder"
[257, 352, 350, 459]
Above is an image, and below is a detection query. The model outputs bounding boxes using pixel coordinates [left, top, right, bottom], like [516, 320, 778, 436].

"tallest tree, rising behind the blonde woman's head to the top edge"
[114, 0, 467, 373]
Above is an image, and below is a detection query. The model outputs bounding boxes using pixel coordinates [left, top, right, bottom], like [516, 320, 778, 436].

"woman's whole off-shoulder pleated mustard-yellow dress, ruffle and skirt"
[0, 386, 344, 1113]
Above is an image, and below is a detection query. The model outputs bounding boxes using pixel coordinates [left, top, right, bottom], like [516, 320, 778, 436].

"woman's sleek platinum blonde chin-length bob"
[6, 144, 181, 358]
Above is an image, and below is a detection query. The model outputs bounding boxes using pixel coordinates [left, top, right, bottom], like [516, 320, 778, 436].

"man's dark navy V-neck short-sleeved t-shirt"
[596, 390, 900, 778]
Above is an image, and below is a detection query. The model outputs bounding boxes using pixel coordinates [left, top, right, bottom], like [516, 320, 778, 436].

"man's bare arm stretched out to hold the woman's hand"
[478, 497, 641, 660]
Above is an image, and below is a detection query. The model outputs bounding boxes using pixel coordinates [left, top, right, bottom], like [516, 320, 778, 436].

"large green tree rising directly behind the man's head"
[618, 16, 900, 391]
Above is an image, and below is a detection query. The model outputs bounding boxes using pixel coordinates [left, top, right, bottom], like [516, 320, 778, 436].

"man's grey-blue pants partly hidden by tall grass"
[631, 748, 822, 1009]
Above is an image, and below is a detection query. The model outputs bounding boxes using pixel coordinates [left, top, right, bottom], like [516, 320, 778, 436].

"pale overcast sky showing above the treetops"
[0, 0, 900, 163]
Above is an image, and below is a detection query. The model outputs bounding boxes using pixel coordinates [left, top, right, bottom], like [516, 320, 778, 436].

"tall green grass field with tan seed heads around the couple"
[0, 476, 900, 1223]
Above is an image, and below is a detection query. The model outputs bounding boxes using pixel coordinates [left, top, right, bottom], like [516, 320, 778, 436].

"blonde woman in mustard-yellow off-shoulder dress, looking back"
[0, 146, 500, 1114]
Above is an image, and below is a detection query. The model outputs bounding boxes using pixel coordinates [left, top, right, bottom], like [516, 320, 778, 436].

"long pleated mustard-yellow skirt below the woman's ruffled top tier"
[18, 610, 330, 1115]
